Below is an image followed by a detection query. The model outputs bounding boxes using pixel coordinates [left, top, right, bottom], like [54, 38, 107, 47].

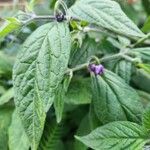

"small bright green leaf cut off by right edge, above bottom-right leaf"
[142, 105, 150, 130]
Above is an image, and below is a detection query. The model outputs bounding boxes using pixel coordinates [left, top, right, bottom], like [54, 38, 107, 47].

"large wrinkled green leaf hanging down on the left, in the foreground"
[13, 22, 71, 150]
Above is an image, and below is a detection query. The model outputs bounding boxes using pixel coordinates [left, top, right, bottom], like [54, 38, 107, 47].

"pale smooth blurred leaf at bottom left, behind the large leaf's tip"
[9, 111, 30, 150]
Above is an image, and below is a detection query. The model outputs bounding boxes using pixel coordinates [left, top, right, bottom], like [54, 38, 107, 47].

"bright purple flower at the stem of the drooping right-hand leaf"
[89, 64, 104, 75]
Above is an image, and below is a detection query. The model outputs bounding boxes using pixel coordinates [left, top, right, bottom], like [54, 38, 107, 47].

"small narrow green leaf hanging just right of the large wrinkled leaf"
[54, 84, 65, 123]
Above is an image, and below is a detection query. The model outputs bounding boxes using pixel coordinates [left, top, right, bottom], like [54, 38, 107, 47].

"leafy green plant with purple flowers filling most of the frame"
[0, 0, 150, 150]
